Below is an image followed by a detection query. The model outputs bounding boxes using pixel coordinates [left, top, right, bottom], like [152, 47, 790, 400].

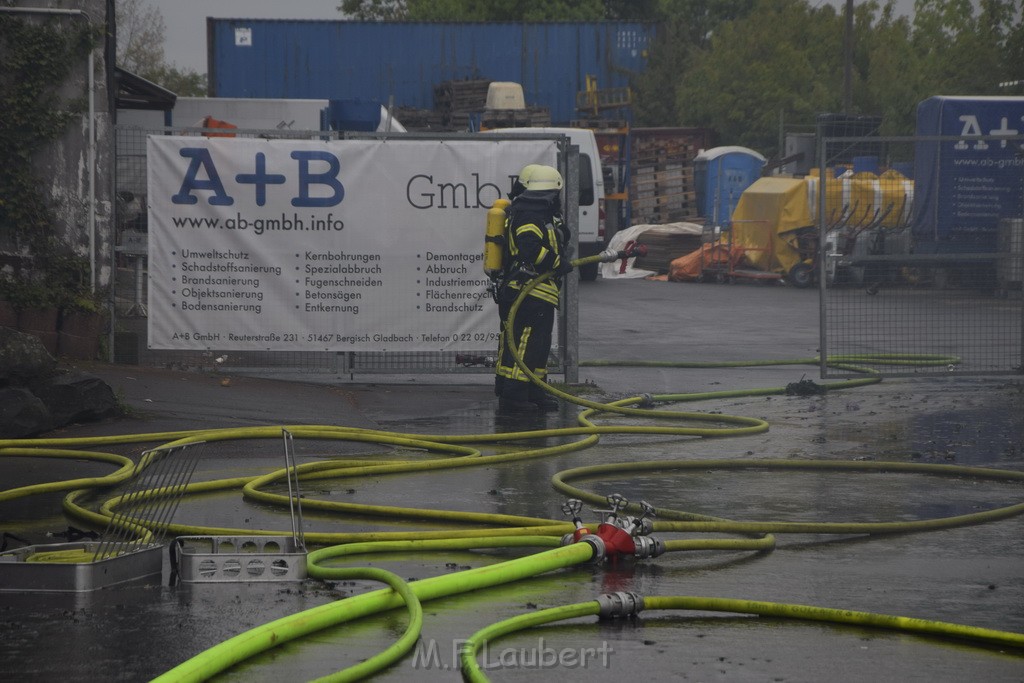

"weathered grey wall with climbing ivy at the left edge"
[0, 0, 114, 305]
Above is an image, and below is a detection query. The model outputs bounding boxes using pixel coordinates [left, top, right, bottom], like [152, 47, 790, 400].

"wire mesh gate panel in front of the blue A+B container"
[809, 135, 1024, 377]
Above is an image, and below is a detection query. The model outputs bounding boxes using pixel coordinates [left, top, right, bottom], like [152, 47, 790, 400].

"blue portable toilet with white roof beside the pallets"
[693, 145, 766, 225]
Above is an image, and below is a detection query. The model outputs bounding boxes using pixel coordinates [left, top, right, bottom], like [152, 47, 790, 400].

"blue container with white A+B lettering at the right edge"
[912, 96, 1024, 253]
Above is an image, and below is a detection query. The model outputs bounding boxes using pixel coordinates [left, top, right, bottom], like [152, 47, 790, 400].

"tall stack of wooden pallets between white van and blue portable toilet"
[630, 136, 698, 225]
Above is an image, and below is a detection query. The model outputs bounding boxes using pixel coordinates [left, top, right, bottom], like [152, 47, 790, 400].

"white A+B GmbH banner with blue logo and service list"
[147, 136, 558, 351]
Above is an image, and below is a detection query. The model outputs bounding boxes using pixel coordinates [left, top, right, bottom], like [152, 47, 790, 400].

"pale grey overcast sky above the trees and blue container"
[148, 0, 913, 74]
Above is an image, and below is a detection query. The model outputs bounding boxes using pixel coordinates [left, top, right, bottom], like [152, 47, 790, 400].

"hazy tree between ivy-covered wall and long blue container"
[114, 0, 206, 96]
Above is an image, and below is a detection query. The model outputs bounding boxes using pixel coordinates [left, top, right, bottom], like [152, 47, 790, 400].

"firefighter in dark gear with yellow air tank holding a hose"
[495, 164, 572, 413]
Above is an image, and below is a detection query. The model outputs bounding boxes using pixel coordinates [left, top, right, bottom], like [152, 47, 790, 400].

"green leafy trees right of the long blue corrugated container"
[663, 0, 1024, 155]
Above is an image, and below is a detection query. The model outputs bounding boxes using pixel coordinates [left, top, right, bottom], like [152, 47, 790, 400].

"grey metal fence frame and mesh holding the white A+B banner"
[111, 126, 579, 382]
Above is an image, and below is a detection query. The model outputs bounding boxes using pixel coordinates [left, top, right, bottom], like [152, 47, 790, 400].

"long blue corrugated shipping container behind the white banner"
[207, 17, 656, 124]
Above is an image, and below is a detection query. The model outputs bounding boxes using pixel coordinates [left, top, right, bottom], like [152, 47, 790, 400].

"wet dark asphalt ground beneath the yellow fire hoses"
[0, 281, 1024, 681]
